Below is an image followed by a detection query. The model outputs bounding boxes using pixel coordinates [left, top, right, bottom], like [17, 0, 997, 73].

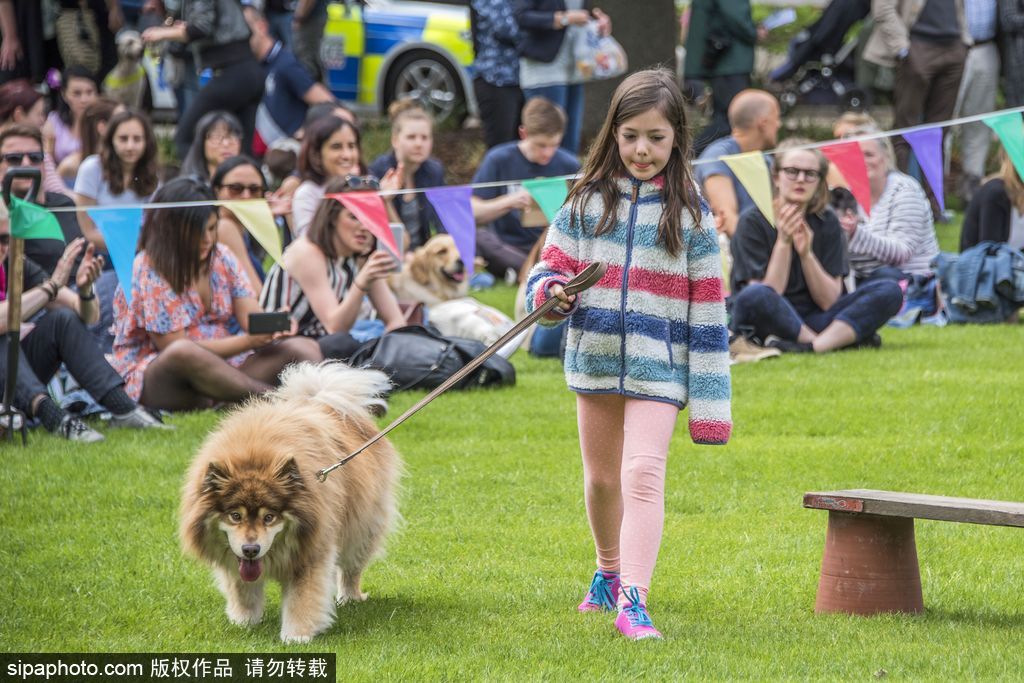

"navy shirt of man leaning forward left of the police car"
[256, 43, 315, 146]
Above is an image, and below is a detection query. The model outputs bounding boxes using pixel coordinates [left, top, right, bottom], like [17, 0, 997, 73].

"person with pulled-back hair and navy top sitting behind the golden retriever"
[370, 99, 444, 249]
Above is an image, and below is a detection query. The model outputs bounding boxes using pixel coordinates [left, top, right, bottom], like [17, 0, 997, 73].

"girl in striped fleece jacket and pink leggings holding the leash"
[526, 70, 732, 639]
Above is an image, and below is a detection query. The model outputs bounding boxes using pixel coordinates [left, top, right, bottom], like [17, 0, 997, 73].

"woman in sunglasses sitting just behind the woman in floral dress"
[213, 156, 267, 287]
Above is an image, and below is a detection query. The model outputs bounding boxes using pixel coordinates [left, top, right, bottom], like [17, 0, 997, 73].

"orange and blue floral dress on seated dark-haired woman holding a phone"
[113, 244, 256, 400]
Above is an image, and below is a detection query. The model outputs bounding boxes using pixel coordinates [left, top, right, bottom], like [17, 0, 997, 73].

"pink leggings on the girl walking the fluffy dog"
[577, 393, 679, 599]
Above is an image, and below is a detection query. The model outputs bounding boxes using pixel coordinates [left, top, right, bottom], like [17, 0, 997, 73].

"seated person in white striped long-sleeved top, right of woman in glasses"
[839, 126, 939, 288]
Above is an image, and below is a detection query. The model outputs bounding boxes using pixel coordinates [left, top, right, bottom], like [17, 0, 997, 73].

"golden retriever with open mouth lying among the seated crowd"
[388, 233, 469, 306]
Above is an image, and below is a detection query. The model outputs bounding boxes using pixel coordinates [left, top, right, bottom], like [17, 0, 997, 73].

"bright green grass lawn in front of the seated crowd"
[6, 241, 1024, 680]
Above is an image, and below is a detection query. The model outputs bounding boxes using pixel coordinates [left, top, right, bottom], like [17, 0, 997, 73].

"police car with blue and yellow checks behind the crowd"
[122, 0, 476, 123]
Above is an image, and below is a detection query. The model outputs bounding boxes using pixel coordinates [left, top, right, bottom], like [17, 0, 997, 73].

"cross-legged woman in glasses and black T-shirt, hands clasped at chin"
[730, 139, 903, 353]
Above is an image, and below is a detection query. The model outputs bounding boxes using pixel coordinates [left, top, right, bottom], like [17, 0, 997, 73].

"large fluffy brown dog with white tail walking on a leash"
[180, 362, 401, 642]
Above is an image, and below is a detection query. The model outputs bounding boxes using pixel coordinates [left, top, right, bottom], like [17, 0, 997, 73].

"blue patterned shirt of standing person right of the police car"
[470, 0, 519, 87]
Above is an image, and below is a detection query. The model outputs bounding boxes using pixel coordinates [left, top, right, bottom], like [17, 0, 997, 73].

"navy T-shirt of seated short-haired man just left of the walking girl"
[473, 141, 580, 251]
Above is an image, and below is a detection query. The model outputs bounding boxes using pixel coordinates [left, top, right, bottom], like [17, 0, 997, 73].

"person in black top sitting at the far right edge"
[959, 151, 1024, 252]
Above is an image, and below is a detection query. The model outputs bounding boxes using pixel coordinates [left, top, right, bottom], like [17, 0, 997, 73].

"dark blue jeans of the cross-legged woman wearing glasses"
[730, 280, 903, 341]
